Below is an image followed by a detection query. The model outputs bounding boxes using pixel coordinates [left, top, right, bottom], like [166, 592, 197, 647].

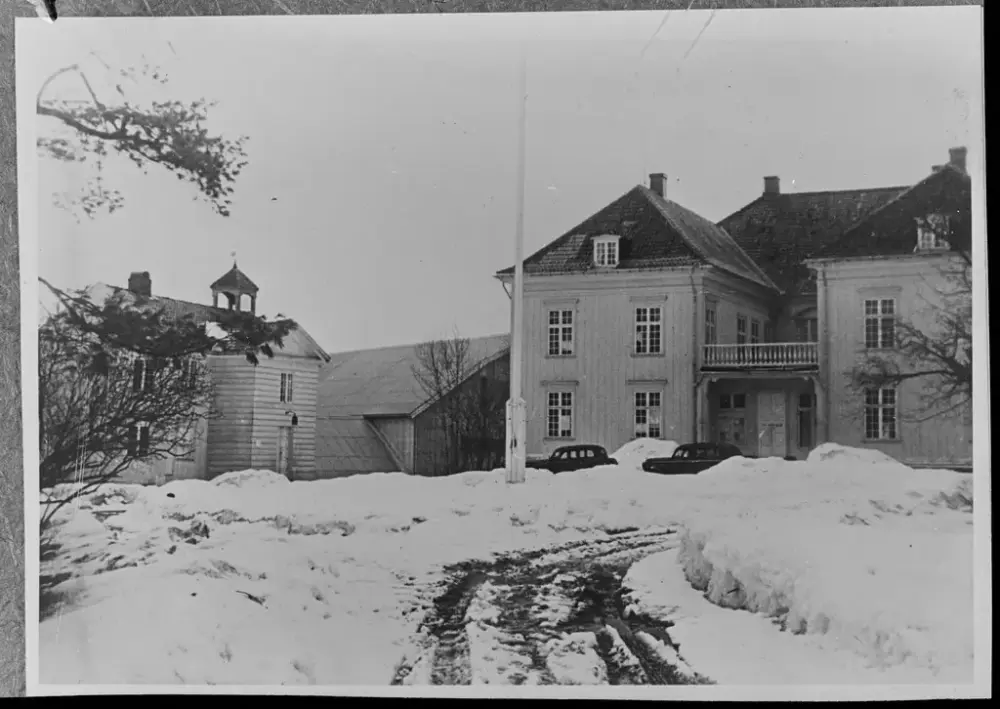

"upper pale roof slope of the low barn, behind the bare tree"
[317, 335, 508, 419]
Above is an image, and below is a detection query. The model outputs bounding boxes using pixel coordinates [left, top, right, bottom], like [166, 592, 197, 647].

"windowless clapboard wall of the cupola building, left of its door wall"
[206, 355, 258, 477]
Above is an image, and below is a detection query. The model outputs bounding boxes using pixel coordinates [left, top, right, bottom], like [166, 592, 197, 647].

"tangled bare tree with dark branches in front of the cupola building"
[38, 279, 296, 525]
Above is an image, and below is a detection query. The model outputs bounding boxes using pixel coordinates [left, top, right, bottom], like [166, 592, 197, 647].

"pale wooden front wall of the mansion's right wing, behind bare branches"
[820, 256, 972, 463]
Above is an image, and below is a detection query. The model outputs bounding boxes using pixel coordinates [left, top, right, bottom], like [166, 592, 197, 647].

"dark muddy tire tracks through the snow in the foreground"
[392, 529, 708, 685]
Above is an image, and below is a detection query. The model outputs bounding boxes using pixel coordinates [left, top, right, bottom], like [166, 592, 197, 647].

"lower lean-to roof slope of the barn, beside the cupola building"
[316, 417, 398, 477]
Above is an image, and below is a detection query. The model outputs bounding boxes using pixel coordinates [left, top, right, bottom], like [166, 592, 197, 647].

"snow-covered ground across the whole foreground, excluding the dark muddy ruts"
[39, 442, 973, 685]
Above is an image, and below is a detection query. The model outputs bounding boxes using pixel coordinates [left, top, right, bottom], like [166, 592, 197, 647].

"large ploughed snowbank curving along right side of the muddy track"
[628, 446, 973, 682]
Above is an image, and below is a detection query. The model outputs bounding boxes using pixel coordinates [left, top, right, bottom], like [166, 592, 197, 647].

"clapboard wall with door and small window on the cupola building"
[251, 354, 320, 479]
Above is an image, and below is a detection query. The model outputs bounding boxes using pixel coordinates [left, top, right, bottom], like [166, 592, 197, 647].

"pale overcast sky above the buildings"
[17, 8, 982, 351]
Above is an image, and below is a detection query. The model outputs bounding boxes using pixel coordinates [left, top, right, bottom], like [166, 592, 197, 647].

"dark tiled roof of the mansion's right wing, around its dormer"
[815, 165, 972, 258]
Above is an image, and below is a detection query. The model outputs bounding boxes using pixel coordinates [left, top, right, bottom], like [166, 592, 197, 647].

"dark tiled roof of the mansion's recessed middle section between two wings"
[719, 187, 907, 292]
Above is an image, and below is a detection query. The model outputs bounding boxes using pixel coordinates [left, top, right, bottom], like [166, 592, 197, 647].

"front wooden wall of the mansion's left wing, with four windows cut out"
[524, 270, 702, 454]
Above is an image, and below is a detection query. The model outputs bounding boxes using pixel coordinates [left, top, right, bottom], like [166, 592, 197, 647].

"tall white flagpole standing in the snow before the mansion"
[506, 47, 528, 483]
